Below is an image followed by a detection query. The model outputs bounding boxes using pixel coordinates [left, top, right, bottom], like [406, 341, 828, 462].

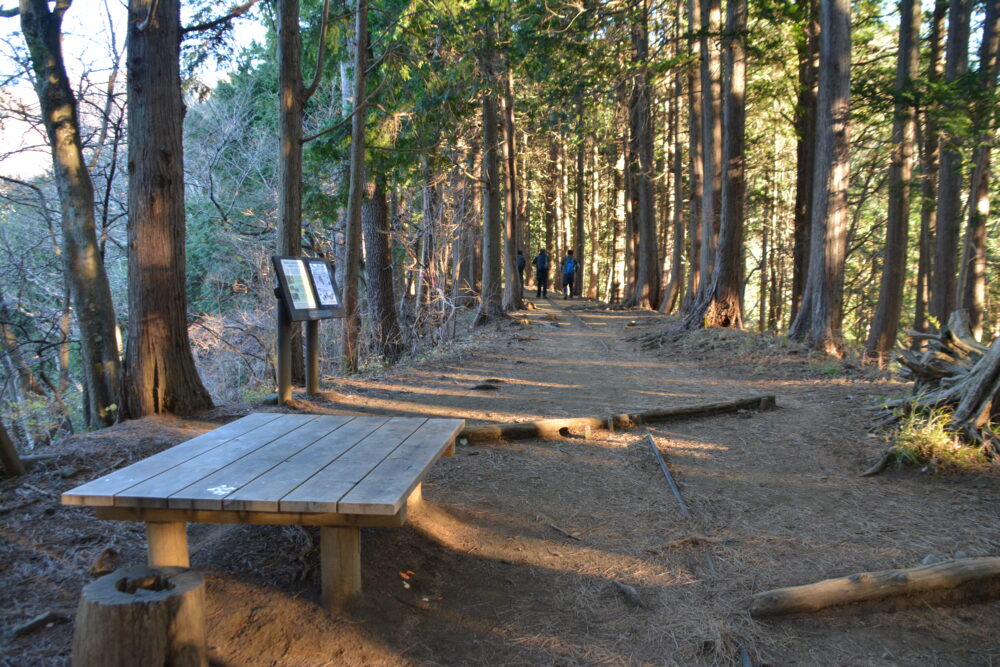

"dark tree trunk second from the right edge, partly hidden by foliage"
[930, 0, 972, 322]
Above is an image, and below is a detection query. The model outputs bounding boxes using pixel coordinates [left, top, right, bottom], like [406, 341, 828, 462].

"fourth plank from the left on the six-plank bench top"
[222, 417, 389, 512]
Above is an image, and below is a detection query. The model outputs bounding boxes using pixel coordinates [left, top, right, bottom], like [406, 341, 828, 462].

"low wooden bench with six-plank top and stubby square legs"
[62, 413, 465, 611]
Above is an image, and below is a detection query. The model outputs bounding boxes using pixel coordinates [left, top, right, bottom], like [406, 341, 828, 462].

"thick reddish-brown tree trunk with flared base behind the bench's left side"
[122, 0, 212, 418]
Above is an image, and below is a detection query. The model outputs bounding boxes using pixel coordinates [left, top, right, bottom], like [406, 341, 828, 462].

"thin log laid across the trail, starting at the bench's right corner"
[458, 395, 776, 442]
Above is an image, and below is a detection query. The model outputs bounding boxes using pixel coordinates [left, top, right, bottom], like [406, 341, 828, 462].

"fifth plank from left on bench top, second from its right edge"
[279, 417, 427, 514]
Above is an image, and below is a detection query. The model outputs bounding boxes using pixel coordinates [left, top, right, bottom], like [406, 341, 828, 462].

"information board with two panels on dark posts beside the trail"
[271, 255, 344, 404]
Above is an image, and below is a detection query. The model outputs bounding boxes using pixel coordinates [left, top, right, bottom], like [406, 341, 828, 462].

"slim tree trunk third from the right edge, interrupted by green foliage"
[913, 0, 948, 336]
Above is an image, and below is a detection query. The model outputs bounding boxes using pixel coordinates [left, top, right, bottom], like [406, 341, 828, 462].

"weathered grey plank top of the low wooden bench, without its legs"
[62, 413, 465, 516]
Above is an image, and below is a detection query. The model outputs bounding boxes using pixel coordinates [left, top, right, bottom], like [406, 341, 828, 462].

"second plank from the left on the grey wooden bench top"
[114, 415, 316, 507]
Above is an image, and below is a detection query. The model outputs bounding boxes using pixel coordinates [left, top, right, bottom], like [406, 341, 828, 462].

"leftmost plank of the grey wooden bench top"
[62, 412, 281, 505]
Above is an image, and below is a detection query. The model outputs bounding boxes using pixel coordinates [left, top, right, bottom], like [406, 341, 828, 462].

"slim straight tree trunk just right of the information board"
[340, 0, 368, 373]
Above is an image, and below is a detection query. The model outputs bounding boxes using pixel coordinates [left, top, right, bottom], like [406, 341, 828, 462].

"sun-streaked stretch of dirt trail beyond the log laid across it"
[306, 296, 760, 423]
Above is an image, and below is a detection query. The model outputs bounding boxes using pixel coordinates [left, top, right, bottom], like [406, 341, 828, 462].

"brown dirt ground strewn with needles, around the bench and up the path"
[0, 298, 1000, 667]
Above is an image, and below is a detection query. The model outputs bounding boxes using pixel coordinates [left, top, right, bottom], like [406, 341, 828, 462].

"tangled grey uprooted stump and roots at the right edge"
[878, 310, 1000, 456]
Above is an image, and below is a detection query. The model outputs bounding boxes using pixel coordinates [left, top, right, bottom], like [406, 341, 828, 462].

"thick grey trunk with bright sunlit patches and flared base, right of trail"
[788, 0, 851, 354]
